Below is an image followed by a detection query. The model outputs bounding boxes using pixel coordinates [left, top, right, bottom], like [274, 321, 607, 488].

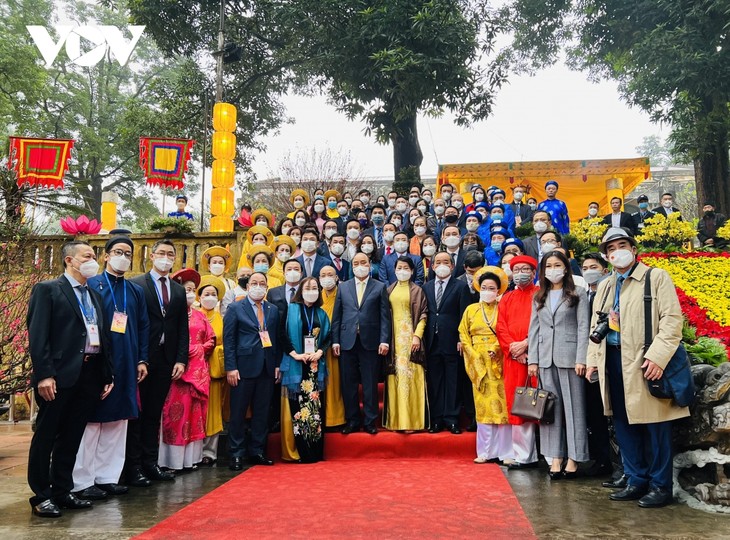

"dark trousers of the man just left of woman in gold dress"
[340, 336, 382, 426]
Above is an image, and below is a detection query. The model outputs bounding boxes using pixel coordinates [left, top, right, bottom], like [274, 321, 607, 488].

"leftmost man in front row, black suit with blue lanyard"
[26, 242, 114, 517]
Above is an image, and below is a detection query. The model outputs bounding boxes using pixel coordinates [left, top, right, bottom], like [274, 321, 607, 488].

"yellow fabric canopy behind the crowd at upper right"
[436, 157, 651, 221]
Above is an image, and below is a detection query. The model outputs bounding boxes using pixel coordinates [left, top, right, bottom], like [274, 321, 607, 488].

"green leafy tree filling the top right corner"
[508, 0, 730, 213]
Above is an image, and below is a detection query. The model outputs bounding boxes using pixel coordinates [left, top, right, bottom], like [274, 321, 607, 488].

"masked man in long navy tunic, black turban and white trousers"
[74, 236, 150, 500]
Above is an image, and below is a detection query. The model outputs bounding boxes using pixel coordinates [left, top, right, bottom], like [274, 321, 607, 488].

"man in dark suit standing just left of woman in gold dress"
[332, 253, 392, 435]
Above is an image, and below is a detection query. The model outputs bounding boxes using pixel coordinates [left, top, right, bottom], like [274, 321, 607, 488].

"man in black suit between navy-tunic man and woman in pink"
[125, 240, 190, 487]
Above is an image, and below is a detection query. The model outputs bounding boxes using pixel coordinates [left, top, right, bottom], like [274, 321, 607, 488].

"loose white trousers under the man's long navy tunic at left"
[73, 420, 128, 491]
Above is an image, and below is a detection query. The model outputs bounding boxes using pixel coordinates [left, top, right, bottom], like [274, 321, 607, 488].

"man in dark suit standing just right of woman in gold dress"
[423, 251, 469, 434]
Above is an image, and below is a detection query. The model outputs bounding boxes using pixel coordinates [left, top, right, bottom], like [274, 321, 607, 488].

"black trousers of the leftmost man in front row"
[28, 360, 103, 506]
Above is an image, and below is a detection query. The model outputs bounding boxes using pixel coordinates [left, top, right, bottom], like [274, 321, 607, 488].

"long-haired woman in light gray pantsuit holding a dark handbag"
[527, 251, 590, 480]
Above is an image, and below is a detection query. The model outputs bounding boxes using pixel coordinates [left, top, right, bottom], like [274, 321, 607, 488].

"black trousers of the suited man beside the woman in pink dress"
[124, 364, 172, 472]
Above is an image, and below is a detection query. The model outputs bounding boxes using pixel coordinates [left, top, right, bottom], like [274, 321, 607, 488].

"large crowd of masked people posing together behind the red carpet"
[27, 181, 688, 517]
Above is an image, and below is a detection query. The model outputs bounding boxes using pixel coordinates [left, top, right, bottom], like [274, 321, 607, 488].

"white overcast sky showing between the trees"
[254, 65, 667, 182]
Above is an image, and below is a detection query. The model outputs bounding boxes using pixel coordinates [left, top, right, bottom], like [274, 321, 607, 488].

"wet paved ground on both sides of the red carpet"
[0, 424, 730, 540]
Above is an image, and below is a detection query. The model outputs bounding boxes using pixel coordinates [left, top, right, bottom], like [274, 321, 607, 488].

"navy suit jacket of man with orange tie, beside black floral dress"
[223, 298, 282, 379]
